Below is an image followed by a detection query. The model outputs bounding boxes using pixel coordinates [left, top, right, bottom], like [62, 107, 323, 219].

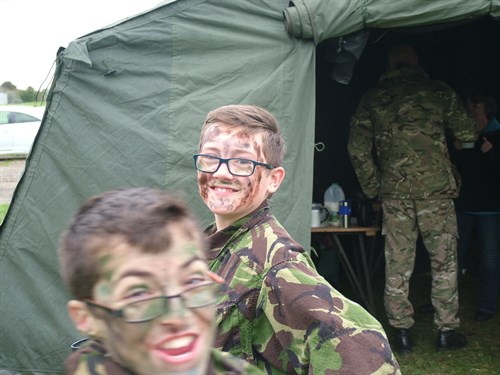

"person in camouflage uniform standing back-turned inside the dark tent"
[348, 45, 477, 353]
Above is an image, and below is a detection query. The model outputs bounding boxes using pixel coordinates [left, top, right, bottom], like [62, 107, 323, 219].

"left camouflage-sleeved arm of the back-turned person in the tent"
[347, 100, 380, 198]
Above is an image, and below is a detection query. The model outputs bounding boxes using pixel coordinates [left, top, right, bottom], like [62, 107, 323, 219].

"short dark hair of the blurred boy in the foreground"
[59, 188, 204, 300]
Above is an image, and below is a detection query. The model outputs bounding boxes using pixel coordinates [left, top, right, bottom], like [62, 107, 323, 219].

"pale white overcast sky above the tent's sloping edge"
[0, 0, 161, 90]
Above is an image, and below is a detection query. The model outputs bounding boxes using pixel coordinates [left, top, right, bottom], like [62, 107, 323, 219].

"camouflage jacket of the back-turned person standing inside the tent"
[348, 68, 477, 203]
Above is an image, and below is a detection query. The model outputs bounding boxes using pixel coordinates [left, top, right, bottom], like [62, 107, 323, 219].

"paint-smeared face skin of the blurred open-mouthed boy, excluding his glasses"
[89, 223, 215, 375]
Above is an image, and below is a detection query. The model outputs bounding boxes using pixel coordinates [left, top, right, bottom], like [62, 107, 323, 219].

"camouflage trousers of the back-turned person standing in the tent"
[382, 199, 460, 330]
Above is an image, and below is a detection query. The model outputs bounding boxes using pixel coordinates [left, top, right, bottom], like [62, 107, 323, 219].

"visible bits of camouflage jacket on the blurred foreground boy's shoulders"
[65, 341, 265, 375]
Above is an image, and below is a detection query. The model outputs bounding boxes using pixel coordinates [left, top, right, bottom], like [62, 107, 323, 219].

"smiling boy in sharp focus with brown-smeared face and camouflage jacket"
[194, 105, 400, 374]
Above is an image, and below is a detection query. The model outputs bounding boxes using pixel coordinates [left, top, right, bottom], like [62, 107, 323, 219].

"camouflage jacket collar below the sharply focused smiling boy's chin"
[204, 201, 269, 261]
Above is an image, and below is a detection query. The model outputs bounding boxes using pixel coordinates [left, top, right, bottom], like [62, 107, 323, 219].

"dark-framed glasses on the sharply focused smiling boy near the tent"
[193, 154, 274, 177]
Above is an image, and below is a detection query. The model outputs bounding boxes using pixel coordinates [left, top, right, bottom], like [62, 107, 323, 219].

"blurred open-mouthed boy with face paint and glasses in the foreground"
[59, 188, 264, 375]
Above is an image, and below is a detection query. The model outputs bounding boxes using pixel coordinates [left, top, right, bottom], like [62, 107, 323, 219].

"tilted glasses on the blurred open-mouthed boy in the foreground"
[85, 283, 221, 323]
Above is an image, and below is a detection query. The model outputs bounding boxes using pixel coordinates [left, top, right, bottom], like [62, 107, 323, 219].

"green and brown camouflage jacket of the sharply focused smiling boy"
[206, 207, 400, 375]
